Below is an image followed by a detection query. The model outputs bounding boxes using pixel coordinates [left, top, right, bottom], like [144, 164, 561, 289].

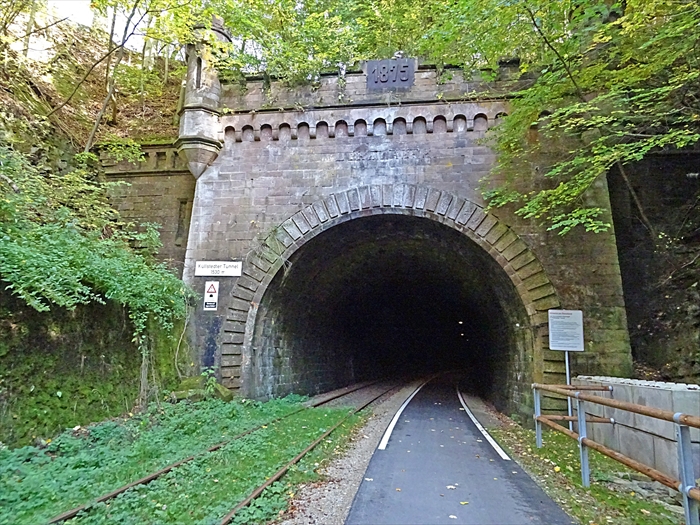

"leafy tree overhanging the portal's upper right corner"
[388, 0, 700, 234]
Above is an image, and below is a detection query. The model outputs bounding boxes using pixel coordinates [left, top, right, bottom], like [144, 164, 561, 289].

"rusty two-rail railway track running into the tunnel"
[48, 381, 399, 525]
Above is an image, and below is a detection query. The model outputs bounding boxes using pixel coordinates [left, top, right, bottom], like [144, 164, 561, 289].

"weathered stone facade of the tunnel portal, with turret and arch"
[100, 60, 631, 411]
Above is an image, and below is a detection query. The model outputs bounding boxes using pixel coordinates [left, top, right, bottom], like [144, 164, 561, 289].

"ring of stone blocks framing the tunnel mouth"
[220, 184, 560, 388]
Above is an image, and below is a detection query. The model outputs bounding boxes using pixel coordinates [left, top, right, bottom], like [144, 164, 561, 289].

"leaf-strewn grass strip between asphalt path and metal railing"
[489, 418, 684, 525]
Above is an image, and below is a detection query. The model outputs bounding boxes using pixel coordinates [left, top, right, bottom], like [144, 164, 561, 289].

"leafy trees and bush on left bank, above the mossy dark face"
[0, 0, 200, 406]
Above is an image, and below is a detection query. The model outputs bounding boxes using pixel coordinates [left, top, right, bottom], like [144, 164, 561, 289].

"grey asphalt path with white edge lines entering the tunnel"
[345, 377, 575, 525]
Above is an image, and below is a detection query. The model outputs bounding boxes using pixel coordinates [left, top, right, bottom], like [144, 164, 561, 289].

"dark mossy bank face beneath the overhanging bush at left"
[0, 316, 139, 446]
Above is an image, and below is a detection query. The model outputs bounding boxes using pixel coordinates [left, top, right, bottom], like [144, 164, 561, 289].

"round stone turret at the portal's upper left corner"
[176, 18, 231, 179]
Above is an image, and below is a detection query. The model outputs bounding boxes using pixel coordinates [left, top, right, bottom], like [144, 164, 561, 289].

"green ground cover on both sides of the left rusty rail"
[0, 396, 366, 525]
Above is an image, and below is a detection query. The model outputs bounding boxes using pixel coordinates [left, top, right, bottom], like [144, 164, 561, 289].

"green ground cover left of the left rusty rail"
[0, 396, 302, 525]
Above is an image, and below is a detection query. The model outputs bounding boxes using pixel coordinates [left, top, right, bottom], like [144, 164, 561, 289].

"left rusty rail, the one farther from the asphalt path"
[47, 379, 382, 525]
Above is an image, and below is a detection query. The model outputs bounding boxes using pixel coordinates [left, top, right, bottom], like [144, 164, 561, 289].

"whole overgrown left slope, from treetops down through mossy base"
[0, 0, 193, 422]
